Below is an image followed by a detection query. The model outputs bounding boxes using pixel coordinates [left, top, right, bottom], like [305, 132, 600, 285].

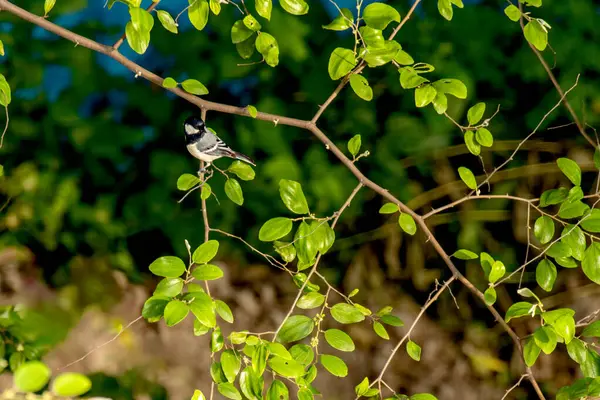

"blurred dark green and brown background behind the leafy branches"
[0, 0, 600, 399]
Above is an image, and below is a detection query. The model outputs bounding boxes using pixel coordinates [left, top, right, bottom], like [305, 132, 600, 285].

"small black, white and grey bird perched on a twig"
[183, 117, 256, 172]
